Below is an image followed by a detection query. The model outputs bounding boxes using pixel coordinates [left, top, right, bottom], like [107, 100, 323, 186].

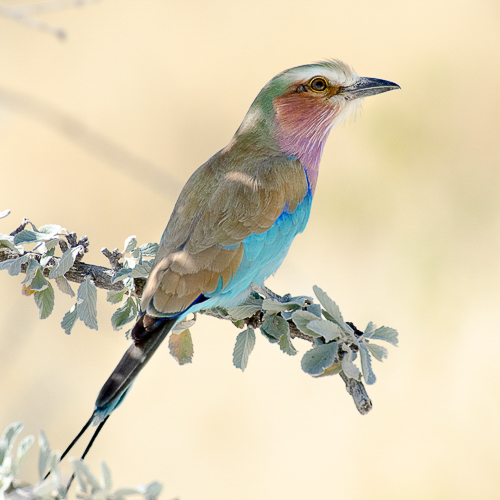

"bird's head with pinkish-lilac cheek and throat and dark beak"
[232, 60, 400, 191]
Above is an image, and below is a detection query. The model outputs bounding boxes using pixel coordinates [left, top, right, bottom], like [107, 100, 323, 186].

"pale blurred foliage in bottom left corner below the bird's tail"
[0, 422, 162, 500]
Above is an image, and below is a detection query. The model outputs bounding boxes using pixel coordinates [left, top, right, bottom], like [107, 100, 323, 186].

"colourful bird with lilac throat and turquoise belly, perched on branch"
[55, 59, 400, 472]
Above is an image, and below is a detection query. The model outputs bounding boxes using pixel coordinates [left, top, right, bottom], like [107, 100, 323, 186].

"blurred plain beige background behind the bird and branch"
[0, 0, 500, 500]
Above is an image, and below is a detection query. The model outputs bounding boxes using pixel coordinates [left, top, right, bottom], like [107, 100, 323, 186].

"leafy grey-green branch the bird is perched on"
[0, 211, 398, 414]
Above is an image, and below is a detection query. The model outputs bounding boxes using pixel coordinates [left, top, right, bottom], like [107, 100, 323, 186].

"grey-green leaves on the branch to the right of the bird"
[226, 286, 397, 384]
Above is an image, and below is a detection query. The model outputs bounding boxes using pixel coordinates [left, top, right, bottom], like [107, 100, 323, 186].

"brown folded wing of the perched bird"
[142, 153, 308, 317]
